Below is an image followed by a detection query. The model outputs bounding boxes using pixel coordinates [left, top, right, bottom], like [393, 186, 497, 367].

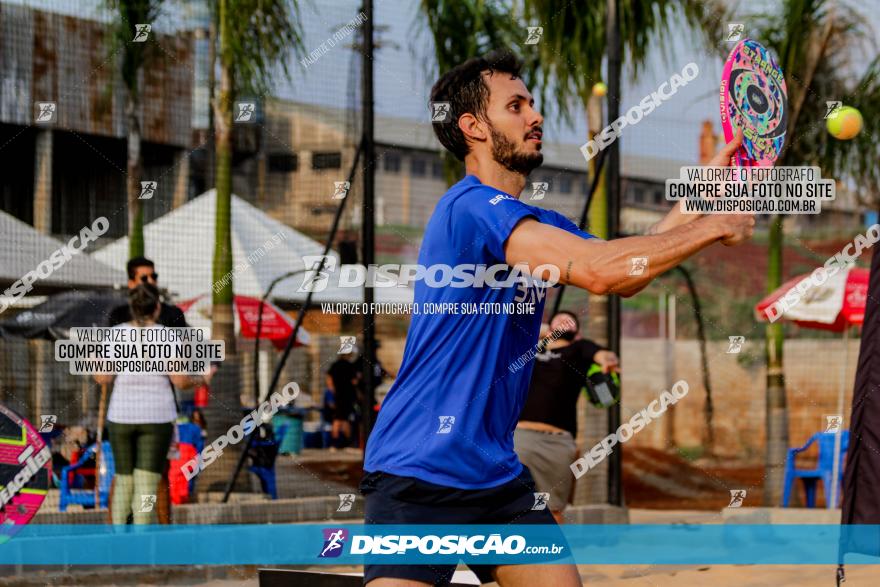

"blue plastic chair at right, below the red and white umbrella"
[782, 430, 849, 509]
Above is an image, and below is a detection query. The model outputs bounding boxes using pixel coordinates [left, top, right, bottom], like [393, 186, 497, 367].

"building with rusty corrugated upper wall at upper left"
[0, 3, 194, 237]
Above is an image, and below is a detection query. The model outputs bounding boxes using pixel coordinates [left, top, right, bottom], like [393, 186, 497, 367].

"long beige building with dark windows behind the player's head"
[244, 100, 689, 248]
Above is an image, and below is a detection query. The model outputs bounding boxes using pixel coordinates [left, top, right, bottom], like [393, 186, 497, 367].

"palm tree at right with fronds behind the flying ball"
[750, 0, 880, 505]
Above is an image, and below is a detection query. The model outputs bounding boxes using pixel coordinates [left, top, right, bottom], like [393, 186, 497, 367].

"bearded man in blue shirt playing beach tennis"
[361, 53, 754, 587]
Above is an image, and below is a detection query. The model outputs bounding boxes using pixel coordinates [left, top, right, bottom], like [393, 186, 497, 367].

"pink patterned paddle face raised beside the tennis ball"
[721, 39, 788, 167]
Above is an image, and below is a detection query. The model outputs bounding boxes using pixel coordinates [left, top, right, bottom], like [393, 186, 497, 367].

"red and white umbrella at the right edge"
[755, 268, 869, 332]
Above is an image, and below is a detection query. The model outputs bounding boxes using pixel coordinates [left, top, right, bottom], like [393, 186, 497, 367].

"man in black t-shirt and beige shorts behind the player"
[513, 311, 619, 523]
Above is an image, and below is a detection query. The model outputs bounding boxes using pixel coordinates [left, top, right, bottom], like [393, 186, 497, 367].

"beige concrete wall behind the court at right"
[621, 337, 859, 459]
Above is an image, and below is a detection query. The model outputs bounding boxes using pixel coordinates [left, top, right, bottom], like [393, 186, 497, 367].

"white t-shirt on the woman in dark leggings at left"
[107, 323, 177, 424]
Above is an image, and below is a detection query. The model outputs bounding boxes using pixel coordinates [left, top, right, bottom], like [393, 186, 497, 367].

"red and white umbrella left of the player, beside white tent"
[177, 295, 309, 349]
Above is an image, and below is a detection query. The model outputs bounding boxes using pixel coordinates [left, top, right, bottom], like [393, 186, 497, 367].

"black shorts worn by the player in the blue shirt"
[360, 467, 568, 585]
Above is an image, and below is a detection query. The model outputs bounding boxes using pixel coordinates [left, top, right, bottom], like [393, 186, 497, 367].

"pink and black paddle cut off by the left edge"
[0, 405, 52, 543]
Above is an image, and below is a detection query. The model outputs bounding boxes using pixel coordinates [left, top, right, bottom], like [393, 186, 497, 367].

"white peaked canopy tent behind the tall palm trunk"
[93, 189, 413, 303]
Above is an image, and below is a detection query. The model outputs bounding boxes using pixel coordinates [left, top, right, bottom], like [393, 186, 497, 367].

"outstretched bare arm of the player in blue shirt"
[504, 210, 755, 295]
